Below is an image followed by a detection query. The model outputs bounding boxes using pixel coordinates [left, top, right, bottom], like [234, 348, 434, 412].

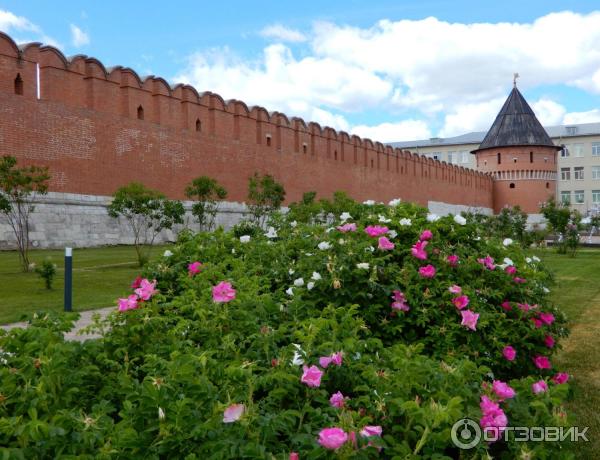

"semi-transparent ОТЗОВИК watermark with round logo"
[450, 418, 589, 449]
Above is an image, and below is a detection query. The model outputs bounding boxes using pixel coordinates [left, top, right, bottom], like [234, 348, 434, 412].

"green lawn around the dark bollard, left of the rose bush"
[0, 246, 171, 324]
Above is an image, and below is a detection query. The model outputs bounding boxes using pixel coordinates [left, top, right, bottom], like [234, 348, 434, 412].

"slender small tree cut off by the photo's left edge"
[0, 156, 50, 272]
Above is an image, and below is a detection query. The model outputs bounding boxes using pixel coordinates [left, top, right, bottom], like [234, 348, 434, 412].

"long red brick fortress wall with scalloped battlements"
[0, 34, 493, 208]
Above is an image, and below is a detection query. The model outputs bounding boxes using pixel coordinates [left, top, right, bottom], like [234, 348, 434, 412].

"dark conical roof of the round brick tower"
[471, 87, 561, 153]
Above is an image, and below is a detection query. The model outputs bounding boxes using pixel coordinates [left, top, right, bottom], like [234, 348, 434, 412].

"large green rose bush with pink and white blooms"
[0, 197, 568, 459]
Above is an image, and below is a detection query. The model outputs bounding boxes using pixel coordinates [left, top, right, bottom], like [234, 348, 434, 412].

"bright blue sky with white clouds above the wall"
[0, 0, 600, 142]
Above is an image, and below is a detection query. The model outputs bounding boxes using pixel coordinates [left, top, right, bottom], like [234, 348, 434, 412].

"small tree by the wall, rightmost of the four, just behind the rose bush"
[248, 173, 285, 227]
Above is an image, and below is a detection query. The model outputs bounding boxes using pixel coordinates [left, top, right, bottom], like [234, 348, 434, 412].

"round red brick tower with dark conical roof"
[471, 83, 561, 214]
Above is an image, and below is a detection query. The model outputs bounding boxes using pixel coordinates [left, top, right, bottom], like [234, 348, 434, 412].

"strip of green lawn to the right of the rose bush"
[538, 249, 600, 459]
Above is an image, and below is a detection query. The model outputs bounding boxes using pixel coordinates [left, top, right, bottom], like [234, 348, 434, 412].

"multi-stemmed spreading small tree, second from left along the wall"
[108, 182, 185, 267]
